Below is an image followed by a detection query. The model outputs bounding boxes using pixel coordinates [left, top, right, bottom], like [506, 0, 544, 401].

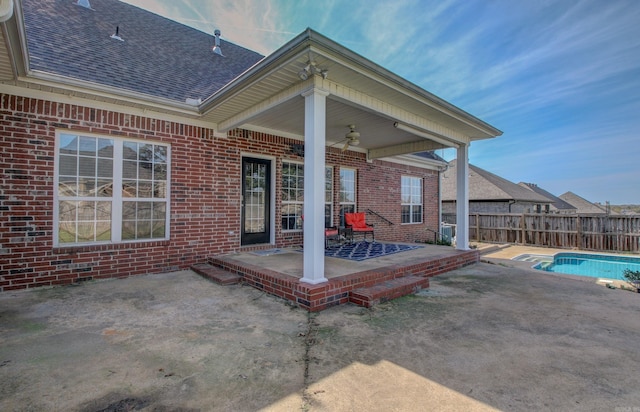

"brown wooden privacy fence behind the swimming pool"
[442, 213, 640, 252]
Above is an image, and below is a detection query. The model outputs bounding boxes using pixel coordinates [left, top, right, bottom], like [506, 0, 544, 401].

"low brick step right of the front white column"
[349, 276, 429, 308]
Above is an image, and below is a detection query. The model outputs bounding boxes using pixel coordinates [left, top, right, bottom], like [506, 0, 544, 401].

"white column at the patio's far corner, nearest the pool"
[456, 144, 469, 250]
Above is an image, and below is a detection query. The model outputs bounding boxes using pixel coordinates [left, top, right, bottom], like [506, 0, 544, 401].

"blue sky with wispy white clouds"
[125, 0, 640, 204]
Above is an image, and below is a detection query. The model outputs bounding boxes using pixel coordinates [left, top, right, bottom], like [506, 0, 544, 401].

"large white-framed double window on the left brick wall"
[54, 133, 169, 245]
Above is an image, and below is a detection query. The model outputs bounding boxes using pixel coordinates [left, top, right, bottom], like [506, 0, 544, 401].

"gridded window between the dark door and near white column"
[282, 162, 304, 230]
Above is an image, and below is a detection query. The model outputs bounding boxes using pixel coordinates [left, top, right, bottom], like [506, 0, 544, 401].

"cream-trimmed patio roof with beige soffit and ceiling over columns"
[202, 29, 501, 158]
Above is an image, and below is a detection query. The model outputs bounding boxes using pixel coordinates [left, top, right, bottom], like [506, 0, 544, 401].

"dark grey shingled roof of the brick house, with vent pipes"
[22, 0, 263, 102]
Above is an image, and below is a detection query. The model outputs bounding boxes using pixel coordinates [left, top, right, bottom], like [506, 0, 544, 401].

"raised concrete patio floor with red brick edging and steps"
[192, 244, 480, 312]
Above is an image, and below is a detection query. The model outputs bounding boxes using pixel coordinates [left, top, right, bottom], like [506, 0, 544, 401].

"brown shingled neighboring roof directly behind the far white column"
[442, 159, 552, 204]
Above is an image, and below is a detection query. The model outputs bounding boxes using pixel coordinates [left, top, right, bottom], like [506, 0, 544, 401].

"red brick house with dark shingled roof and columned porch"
[0, 0, 501, 291]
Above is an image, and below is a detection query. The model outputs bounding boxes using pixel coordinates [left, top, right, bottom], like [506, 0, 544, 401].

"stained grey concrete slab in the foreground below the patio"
[0, 261, 640, 411]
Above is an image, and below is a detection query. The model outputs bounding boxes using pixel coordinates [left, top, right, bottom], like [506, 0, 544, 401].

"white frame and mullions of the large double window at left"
[53, 130, 171, 247]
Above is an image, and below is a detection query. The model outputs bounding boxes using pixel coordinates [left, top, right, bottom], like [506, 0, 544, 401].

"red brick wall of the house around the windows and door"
[0, 94, 438, 291]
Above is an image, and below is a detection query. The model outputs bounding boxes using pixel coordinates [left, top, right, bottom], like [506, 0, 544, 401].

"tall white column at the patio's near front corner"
[300, 88, 328, 284]
